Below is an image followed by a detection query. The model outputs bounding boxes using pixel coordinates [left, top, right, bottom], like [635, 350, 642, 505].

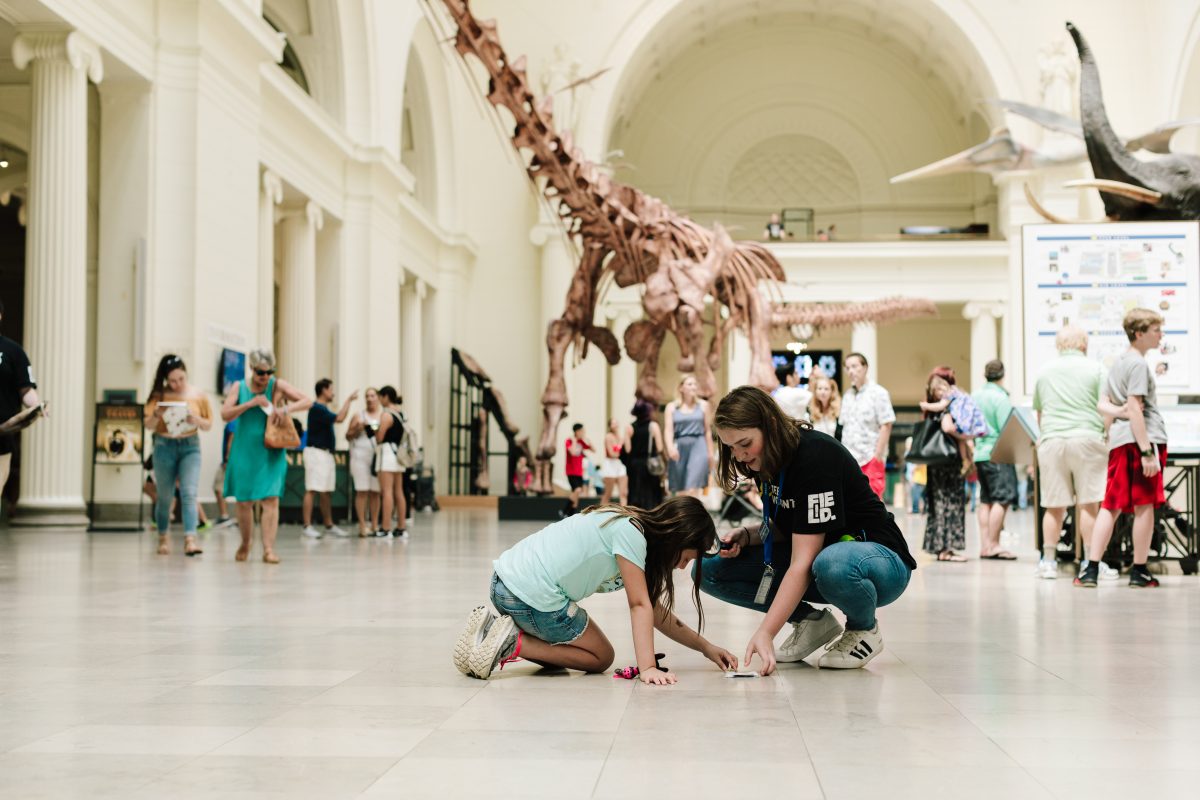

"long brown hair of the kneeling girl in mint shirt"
[583, 497, 716, 630]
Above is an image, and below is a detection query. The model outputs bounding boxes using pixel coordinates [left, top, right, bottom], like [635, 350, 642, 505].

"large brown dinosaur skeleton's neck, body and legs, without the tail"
[434, 0, 786, 491]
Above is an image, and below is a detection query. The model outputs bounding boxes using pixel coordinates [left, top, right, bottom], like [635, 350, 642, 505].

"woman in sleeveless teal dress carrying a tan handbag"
[221, 349, 312, 564]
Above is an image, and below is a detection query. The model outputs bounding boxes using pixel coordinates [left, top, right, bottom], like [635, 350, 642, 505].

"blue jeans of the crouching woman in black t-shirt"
[697, 542, 912, 631]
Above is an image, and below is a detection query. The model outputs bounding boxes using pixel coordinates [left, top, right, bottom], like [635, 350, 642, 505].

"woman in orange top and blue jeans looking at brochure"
[144, 354, 212, 555]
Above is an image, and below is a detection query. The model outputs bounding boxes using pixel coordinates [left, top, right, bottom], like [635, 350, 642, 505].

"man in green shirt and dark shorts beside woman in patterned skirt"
[971, 359, 1016, 561]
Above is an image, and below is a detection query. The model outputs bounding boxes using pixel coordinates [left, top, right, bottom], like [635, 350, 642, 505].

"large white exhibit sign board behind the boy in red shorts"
[1021, 222, 1200, 395]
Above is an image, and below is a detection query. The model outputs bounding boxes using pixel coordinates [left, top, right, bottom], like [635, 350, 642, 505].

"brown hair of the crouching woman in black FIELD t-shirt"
[713, 386, 812, 494]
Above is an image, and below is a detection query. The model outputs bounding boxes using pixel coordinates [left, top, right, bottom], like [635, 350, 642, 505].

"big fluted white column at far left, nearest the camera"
[12, 31, 103, 527]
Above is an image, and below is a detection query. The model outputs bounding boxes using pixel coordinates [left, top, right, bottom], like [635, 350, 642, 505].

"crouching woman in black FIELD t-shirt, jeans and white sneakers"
[700, 386, 917, 675]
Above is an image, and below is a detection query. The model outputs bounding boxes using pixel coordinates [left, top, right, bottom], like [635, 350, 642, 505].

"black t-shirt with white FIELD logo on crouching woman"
[763, 431, 917, 570]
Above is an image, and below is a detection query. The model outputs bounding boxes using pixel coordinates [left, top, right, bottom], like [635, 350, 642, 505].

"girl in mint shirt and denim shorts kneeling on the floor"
[454, 497, 737, 684]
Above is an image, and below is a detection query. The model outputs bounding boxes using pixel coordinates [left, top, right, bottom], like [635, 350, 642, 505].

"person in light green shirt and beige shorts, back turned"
[1033, 326, 1117, 579]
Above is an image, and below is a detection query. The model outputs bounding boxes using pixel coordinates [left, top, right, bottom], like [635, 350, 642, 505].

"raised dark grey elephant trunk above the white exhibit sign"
[1067, 23, 1152, 217]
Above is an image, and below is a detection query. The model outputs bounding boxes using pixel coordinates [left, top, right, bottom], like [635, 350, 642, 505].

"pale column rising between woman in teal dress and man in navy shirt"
[276, 200, 324, 393]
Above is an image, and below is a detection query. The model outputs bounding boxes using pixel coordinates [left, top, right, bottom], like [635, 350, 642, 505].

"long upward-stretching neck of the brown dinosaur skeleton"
[443, 0, 637, 252]
